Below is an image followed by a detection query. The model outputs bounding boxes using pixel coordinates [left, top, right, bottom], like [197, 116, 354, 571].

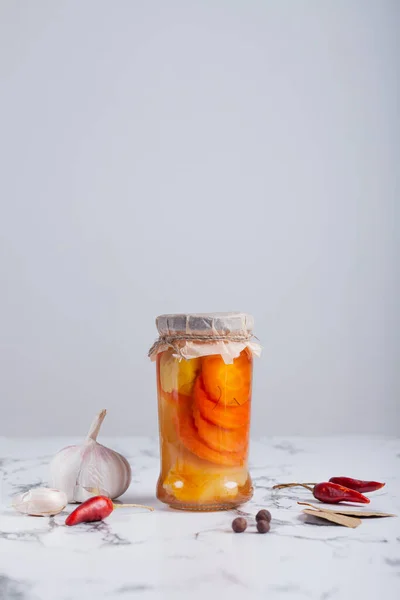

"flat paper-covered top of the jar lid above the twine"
[156, 312, 254, 337]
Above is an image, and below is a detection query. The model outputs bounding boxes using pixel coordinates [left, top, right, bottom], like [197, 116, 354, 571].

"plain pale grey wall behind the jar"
[0, 0, 400, 435]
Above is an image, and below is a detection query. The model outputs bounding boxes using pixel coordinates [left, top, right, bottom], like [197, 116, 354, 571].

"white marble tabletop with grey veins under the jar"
[0, 437, 400, 600]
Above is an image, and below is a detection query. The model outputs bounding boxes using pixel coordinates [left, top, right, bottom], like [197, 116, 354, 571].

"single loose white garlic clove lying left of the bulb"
[12, 488, 68, 517]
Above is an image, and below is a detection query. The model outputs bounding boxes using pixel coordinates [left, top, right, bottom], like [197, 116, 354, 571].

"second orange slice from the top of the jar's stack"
[193, 376, 250, 429]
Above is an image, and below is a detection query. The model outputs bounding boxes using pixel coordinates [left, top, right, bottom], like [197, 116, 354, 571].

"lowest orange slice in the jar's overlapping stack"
[176, 403, 246, 466]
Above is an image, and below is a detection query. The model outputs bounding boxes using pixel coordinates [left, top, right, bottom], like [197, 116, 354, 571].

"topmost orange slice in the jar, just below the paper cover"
[203, 350, 252, 406]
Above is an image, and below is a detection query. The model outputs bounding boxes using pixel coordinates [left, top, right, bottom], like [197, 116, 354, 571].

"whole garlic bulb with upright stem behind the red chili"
[50, 410, 132, 502]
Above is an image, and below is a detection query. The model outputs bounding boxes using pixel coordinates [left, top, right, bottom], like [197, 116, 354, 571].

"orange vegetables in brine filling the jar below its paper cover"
[157, 350, 253, 510]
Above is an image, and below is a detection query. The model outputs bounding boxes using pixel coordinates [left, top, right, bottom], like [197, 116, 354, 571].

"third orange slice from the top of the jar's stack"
[193, 405, 247, 452]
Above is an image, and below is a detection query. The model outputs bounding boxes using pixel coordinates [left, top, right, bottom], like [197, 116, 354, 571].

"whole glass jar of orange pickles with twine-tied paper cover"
[149, 313, 260, 510]
